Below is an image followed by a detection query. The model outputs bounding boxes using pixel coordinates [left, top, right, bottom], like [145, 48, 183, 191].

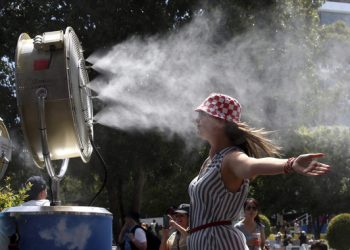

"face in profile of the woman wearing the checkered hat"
[196, 111, 225, 140]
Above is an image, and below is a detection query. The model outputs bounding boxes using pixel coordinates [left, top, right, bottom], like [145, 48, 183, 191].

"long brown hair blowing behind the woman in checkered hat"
[225, 122, 281, 158]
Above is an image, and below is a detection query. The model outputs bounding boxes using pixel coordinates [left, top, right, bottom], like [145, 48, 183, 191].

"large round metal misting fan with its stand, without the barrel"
[16, 27, 93, 205]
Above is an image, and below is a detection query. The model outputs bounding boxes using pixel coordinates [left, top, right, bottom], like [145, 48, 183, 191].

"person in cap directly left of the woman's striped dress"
[159, 204, 190, 250]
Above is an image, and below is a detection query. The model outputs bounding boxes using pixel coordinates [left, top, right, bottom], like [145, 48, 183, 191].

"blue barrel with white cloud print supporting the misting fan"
[4, 206, 113, 250]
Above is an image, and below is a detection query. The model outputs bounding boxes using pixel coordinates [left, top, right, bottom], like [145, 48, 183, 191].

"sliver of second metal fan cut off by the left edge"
[0, 118, 12, 180]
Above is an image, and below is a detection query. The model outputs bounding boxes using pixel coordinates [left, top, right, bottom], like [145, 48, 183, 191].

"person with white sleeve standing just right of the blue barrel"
[118, 211, 147, 250]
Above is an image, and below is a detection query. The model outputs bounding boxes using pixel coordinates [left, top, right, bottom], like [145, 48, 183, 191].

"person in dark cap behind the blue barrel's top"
[21, 176, 50, 206]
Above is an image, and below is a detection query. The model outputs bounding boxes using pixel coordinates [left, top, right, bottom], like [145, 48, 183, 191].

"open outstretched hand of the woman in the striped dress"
[292, 153, 331, 176]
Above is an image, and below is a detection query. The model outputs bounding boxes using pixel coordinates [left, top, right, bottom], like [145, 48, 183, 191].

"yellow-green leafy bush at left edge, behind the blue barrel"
[0, 177, 31, 211]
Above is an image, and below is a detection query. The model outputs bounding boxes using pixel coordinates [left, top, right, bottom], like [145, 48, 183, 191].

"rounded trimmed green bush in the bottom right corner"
[327, 213, 350, 250]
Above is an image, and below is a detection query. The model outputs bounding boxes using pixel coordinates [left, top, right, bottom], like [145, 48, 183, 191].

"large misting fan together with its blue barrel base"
[0, 27, 113, 250]
